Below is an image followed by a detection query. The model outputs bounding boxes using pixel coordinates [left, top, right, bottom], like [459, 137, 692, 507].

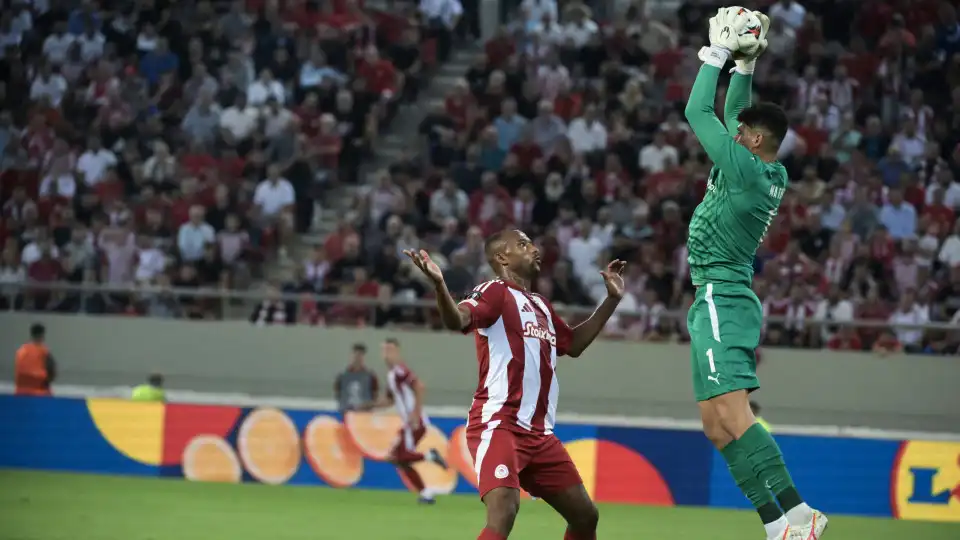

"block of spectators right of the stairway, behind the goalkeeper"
[294, 0, 960, 354]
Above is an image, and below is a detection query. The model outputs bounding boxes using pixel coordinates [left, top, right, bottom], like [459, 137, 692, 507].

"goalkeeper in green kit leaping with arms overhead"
[686, 8, 827, 540]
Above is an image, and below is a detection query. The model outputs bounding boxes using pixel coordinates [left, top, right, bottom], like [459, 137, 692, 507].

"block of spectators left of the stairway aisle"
[0, 0, 449, 318]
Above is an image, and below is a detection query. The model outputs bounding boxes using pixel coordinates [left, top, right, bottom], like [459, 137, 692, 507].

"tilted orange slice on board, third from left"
[303, 414, 363, 487]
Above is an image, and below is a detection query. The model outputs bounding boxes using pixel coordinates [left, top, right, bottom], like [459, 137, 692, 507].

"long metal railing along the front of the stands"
[0, 281, 958, 332]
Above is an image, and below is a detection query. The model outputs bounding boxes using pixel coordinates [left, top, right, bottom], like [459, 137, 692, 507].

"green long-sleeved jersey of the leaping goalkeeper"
[686, 65, 788, 286]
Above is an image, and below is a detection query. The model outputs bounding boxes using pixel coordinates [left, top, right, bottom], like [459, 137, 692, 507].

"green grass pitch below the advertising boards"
[0, 470, 960, 540]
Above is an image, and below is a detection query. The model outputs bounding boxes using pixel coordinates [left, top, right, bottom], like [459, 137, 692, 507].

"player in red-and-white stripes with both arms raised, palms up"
[406, 230, 624, 540]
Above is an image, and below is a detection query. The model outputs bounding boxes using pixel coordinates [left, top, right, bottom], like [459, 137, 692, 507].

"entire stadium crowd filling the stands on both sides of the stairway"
[0, 0, 960, 354]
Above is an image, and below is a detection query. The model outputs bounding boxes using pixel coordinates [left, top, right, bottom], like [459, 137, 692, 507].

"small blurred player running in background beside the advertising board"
[368, 338, 447, 504]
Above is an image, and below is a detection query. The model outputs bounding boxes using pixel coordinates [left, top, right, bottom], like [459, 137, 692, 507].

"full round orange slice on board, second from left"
[237, 408, 300, 484]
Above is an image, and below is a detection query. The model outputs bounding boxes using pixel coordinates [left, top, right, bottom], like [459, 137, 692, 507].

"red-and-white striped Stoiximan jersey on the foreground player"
[460, 279, 573, 434]
